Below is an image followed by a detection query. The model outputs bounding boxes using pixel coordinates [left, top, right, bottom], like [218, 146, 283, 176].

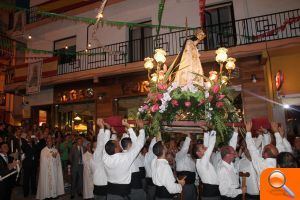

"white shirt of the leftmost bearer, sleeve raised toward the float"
[90, 129, 110, 186]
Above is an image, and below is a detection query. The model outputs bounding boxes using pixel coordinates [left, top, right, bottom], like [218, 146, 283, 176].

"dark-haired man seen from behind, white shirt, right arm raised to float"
[103, 120, 145, 200]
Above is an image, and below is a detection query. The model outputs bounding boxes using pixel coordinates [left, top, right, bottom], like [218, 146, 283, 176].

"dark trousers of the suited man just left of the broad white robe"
[23, 166, 36, 197]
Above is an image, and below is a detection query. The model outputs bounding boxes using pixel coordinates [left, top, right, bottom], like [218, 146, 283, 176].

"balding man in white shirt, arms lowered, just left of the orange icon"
[217, 143, 246, 200]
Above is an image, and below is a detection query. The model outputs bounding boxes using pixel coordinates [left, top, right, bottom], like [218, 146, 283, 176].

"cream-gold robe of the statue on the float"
[174, 40, 203, 86]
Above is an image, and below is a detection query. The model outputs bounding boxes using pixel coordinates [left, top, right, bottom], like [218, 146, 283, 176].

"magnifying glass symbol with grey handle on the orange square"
[269, 170, 295, 197]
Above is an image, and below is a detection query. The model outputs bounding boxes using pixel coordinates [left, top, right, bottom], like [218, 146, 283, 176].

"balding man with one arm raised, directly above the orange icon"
[246, 122, 278, 188]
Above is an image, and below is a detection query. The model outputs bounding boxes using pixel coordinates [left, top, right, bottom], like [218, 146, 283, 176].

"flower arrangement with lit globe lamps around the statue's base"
[138, 48, 240, 141]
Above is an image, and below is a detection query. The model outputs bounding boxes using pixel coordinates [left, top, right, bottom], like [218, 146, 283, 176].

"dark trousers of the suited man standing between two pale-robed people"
[71, 165, 83, 195]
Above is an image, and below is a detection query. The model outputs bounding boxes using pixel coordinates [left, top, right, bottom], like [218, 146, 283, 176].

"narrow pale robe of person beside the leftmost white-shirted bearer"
[82, 151, 94, 199]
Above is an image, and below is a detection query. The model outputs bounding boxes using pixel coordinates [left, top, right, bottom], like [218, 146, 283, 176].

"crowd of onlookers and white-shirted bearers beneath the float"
[0, 119, 300, 200]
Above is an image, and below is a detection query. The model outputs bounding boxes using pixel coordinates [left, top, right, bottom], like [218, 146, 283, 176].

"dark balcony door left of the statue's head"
[129, 21, 153, 62]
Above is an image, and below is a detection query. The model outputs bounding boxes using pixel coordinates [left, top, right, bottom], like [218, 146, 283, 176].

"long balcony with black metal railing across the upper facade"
[57, 9, 300, 75]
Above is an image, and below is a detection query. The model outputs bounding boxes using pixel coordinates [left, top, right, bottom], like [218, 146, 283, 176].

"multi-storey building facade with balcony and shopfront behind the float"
[1, 0, 300, 134]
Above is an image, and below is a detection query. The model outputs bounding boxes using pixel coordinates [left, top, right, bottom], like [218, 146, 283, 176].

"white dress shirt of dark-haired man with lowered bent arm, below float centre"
[151, 159, 182, 194]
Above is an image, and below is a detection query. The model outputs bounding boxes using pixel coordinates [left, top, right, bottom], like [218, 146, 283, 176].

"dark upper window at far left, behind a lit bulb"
[54, 36, 76, 64]
